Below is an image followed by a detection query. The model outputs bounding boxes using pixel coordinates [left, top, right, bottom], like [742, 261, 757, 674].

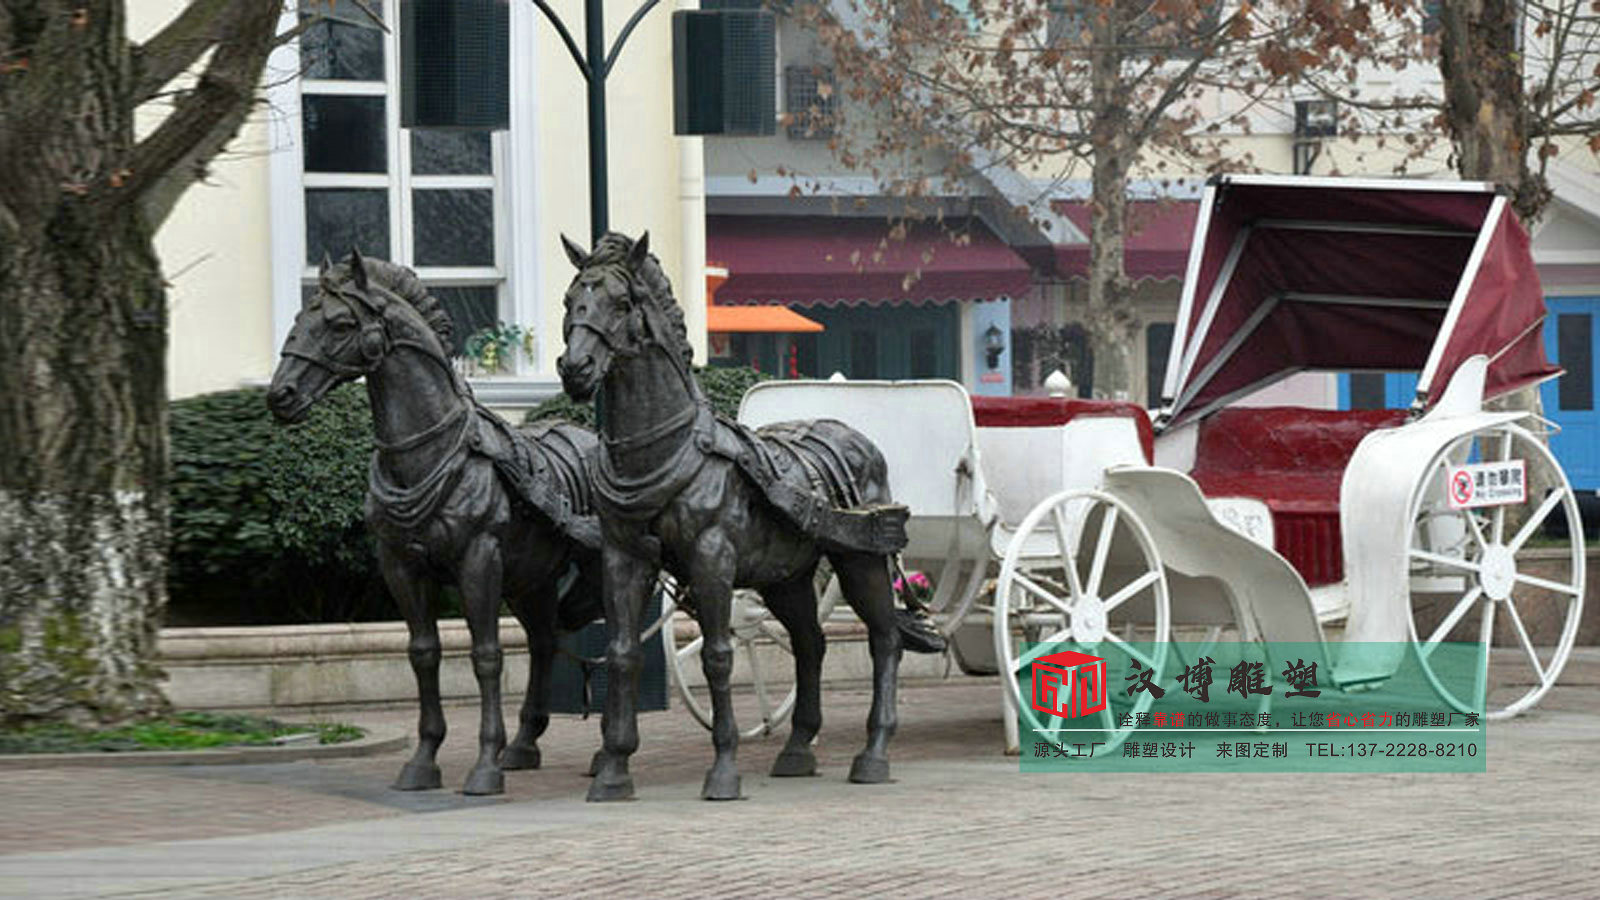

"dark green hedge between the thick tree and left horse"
[168, 384, 395, 625]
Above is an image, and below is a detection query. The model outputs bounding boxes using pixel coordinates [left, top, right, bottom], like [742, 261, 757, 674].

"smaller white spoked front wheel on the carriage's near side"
[995, 490, 1171, 754]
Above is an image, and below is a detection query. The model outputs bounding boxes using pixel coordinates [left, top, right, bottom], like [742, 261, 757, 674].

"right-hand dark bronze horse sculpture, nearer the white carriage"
[557, 234, 906, 801]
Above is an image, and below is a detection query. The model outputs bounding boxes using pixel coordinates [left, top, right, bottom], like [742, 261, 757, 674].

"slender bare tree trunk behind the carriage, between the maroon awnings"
[1083, 8, 1139, 399]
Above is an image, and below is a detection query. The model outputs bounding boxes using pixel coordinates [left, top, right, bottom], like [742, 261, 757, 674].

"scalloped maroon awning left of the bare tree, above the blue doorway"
[706, 216, 1034, 306]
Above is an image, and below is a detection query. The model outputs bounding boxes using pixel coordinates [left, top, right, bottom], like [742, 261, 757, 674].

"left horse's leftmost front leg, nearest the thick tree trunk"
[378, 543, 445, 791]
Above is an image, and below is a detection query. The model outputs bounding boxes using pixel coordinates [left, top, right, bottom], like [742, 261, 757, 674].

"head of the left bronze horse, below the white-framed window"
[267, 250, 443, 423]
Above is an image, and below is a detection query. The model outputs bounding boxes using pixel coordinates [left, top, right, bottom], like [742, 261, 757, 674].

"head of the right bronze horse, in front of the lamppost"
[555, 232, 653, 402]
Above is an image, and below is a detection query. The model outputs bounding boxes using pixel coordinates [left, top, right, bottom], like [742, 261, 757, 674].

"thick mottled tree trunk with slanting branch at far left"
[0, 0, 282, 725]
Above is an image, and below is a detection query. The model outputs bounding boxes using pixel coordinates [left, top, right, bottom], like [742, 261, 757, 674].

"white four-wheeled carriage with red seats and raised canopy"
[675, 176, 1586, 749]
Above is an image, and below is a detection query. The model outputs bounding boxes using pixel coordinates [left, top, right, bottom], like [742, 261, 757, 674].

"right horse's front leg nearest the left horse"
[589, 543, 656, 802]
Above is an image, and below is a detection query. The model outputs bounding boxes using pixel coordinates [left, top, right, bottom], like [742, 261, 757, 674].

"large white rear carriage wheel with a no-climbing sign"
[1406, 424, 1584, 719]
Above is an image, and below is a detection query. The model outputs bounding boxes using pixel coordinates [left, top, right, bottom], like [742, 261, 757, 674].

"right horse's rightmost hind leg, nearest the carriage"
[830, 552, 901, 785]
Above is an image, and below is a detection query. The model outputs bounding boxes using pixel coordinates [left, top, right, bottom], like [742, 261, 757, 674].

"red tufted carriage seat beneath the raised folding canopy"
[1190, 407, 1406, 586]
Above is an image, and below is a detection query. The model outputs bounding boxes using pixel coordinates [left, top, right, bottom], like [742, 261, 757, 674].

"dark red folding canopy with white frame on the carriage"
[1163, 176, 1560, 421]
